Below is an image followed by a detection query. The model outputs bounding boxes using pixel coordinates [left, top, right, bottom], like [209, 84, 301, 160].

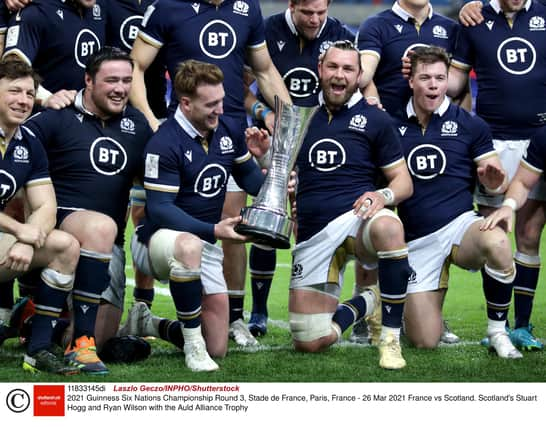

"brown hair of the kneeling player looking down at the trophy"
[173, 59, 224, 98]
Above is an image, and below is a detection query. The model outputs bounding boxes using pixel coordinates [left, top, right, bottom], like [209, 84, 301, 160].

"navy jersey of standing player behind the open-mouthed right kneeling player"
[357, 3, 458, 117]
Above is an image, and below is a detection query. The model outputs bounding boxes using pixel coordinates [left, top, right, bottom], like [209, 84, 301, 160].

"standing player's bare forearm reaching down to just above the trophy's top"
[248, 45, 292, 105]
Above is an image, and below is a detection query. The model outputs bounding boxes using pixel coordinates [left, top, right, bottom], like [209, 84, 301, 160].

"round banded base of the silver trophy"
[235, 207, 294, 249]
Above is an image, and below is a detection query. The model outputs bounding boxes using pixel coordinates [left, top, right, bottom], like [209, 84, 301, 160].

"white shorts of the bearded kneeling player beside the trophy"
[290, 209, 398, 298]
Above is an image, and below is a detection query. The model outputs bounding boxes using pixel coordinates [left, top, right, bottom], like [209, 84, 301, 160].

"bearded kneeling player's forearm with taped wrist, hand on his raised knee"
[353, 159, 413, 219]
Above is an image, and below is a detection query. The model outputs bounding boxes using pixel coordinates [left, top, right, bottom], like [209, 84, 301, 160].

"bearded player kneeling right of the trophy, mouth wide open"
[289, 41, 412, 369]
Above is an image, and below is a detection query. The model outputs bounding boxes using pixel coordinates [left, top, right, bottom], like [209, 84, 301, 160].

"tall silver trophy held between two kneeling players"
[235, 97, 317, 249]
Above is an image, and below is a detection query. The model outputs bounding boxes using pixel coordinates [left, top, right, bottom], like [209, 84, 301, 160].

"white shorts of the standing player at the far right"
[474, 139, 546, 208]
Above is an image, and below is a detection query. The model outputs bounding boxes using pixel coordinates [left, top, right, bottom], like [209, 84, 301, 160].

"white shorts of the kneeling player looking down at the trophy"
[131, 228, 227, 295]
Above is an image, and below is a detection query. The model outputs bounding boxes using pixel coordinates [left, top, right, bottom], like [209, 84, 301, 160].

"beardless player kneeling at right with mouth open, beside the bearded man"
[397, 47, 522, 358]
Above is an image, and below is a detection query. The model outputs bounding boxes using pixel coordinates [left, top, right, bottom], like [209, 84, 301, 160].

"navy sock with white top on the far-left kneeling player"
[27, 269, 73, 356]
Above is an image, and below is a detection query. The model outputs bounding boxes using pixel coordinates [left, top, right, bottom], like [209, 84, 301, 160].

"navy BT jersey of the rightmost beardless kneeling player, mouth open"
[396, 98, 495, 241]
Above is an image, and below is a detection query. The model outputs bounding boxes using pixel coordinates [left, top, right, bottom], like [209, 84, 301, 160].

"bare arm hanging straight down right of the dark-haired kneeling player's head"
[129, 37, 159, 132]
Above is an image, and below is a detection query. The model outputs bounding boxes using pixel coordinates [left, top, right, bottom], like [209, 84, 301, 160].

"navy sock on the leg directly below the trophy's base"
[249, 245, 277, 316]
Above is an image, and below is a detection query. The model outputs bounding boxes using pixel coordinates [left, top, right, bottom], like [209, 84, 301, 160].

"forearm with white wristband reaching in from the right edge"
[480, 163, 541, 232]
